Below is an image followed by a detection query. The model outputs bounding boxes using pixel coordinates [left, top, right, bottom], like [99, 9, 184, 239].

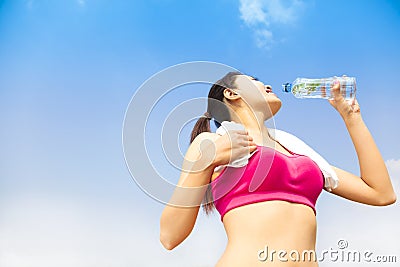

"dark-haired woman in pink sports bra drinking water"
[160, 72, 396, 267]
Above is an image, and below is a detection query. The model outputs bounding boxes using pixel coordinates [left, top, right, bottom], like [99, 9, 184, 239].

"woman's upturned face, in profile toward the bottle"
[230, 75, 282, 119]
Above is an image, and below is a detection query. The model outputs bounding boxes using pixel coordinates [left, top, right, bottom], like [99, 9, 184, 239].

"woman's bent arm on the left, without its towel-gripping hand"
[160, 134, 214, 250]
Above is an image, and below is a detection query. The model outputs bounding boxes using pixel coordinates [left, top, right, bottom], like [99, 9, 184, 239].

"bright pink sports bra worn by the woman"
[211, 145, 324, 221]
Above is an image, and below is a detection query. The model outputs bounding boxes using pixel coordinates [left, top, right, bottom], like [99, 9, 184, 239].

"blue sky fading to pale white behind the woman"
[0, 0, 400, 267]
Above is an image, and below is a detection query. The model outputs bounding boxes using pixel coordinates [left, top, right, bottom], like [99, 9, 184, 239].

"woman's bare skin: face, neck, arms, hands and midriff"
[160, 75, 396, 267]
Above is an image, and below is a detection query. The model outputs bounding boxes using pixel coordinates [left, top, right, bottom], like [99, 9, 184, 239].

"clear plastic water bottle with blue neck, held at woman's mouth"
[282, 76, 356, 100]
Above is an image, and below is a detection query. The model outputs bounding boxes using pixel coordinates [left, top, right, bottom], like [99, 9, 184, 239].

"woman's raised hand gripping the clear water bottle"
[328, 80, 361, 120]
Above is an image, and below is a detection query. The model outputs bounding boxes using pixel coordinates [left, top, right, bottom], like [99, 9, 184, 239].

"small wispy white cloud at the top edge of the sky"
[239, 0, 305, 48]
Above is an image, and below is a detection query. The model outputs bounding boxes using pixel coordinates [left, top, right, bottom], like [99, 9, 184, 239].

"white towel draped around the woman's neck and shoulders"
[216, 121, 339, 192]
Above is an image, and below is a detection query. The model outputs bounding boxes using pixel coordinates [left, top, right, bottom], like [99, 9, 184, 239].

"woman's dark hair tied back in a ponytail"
[190, 71, 242, 215]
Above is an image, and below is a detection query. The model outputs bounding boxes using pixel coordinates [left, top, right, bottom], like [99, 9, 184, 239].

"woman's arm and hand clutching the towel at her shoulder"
[160, 131, 257, 250]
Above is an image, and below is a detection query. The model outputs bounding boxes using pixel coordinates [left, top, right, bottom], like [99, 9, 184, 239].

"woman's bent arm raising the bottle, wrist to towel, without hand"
[332, 115, 396, 206]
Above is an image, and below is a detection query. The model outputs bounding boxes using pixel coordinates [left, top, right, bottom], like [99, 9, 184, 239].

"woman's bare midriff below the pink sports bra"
[215, 200, 318, 267]
